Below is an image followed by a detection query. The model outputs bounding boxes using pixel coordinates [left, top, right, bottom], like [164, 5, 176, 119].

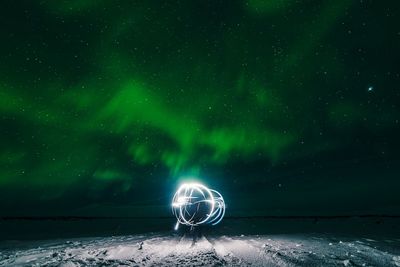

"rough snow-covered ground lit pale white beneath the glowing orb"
[0, 232, 400, 266]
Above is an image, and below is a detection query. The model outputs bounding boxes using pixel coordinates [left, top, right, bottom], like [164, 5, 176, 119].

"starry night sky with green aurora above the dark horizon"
[0, 0, 400, 216]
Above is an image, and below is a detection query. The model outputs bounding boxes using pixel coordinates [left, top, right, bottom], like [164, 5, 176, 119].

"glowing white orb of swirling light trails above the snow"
[172, 183, 225, 230]
